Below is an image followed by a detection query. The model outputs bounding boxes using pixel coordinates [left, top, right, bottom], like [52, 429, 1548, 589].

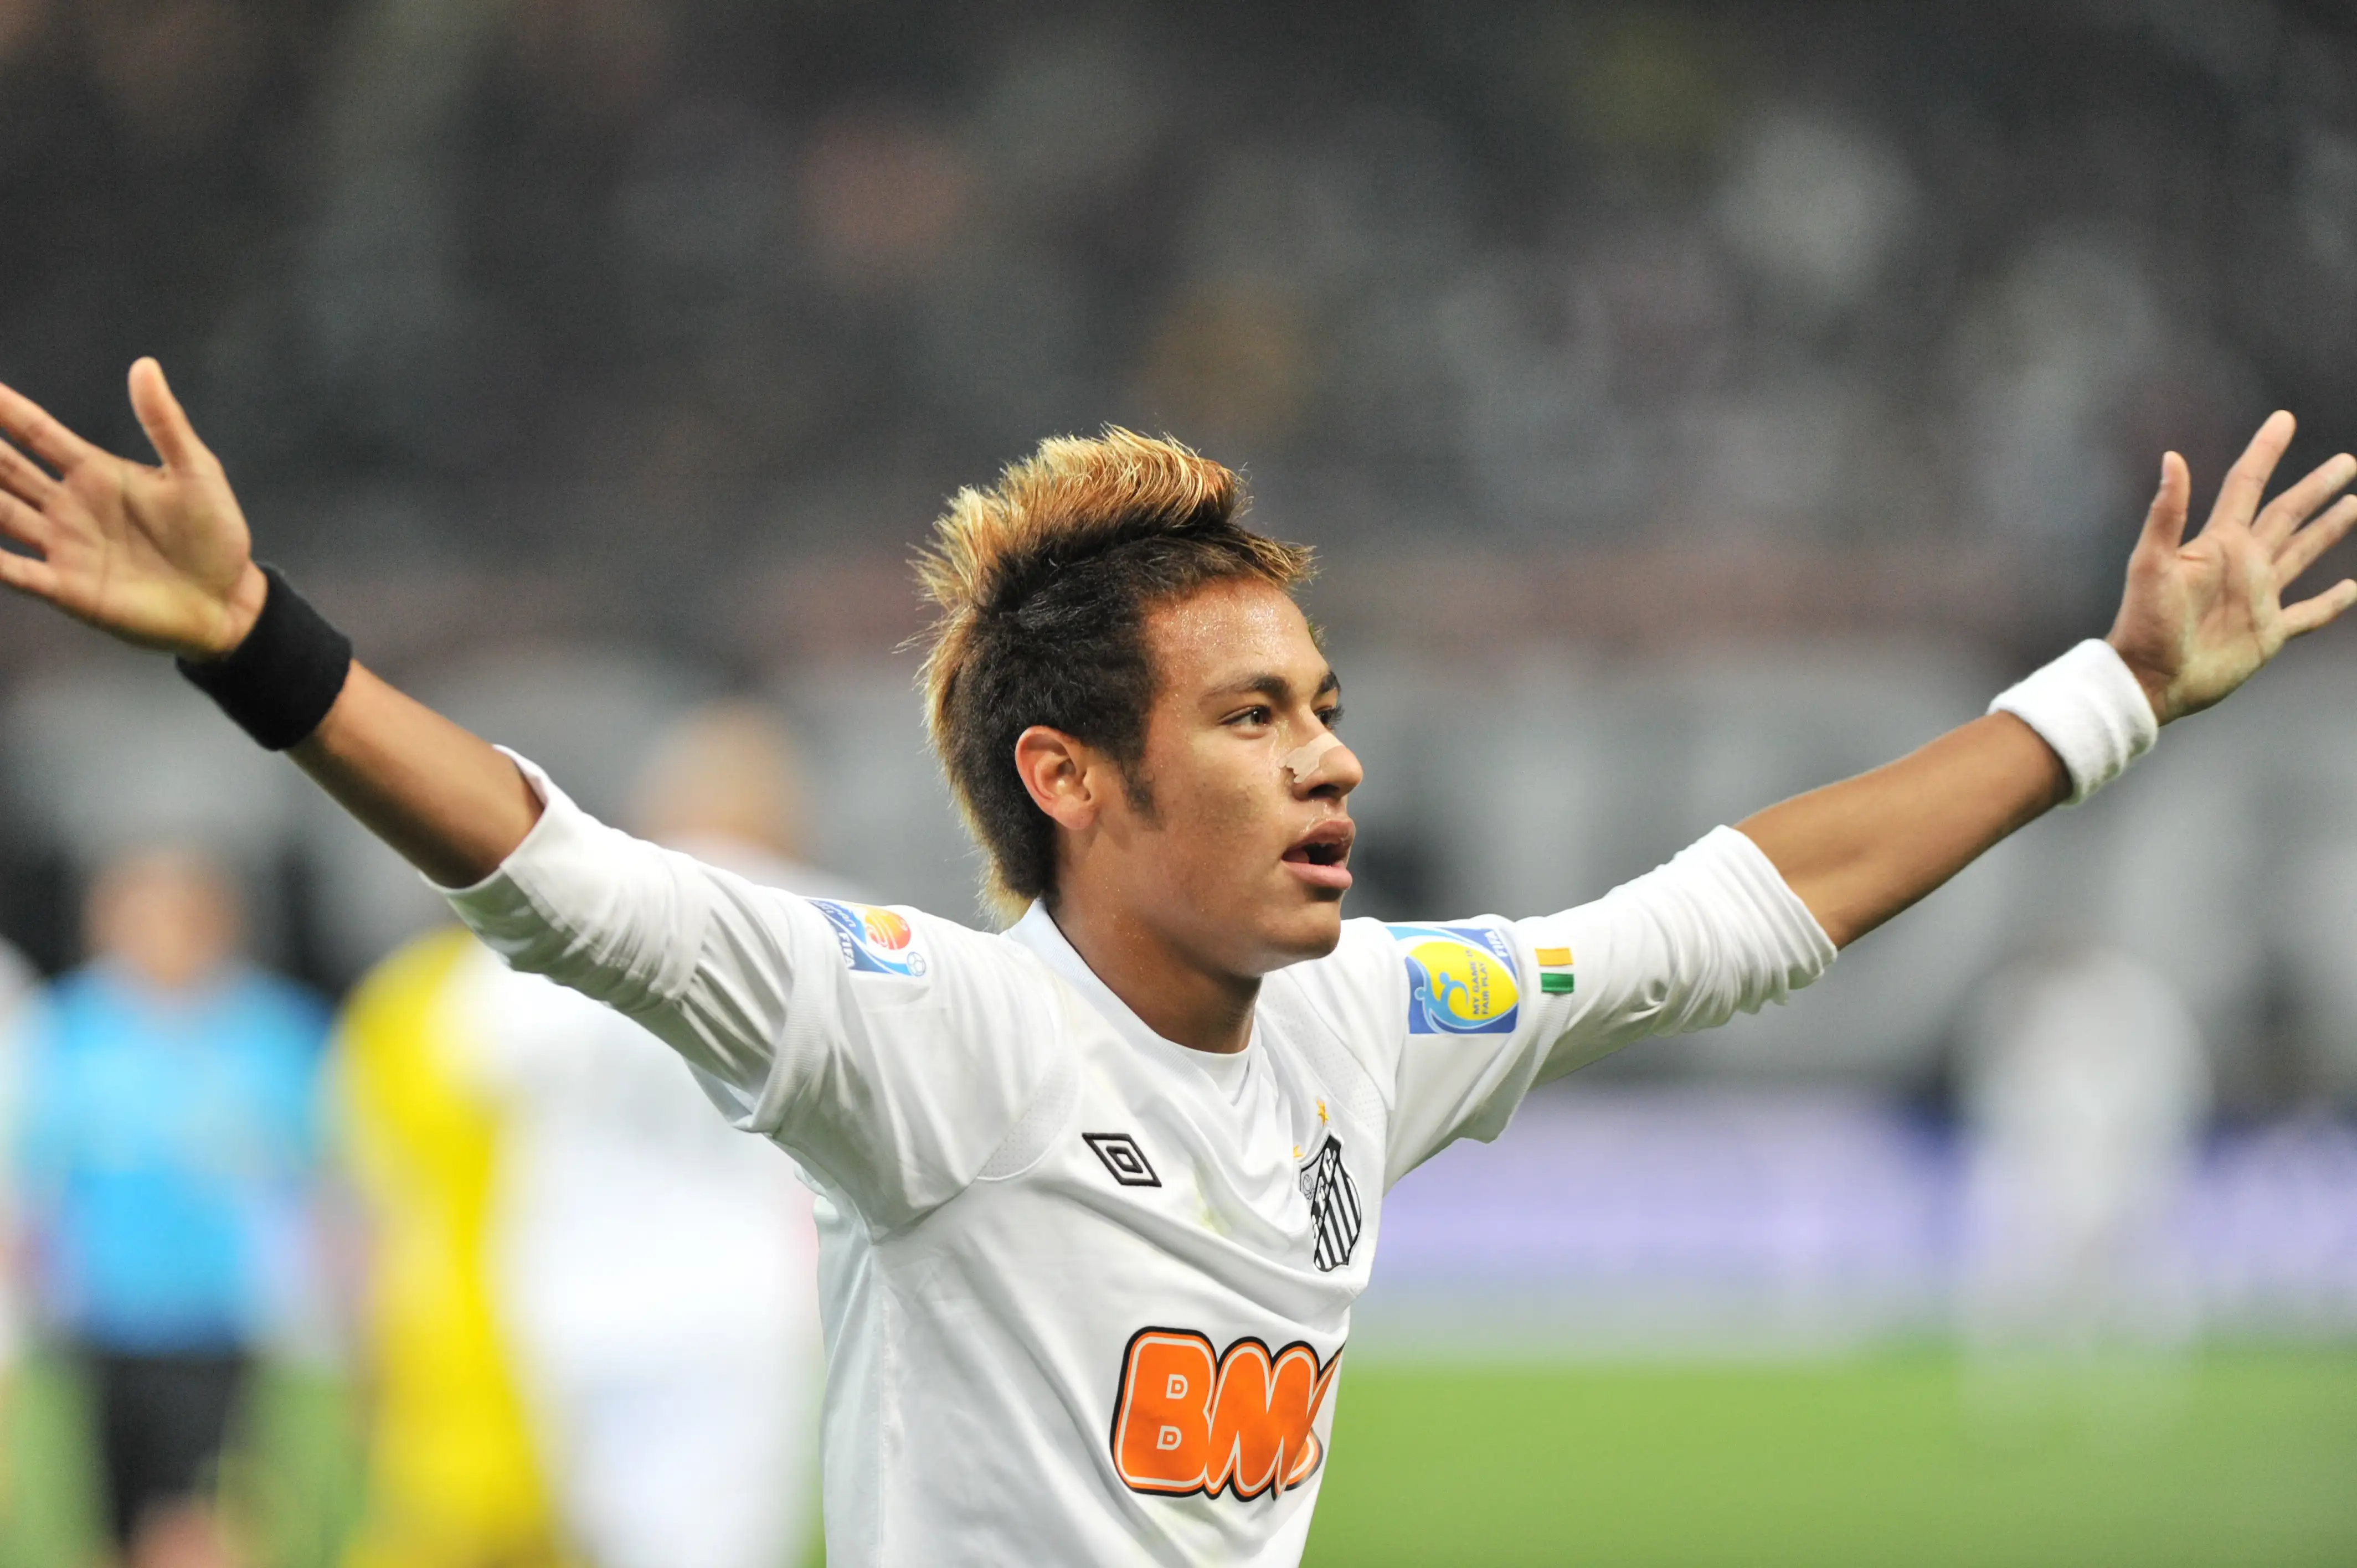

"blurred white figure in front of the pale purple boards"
[1963, 946, 2211, 1368]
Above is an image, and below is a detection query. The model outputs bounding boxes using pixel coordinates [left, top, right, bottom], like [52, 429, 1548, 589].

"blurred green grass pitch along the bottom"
[0, 1349, 2357, 1568]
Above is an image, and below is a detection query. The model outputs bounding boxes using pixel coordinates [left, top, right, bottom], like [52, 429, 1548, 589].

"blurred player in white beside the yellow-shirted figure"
[455, 703, 846, 1568]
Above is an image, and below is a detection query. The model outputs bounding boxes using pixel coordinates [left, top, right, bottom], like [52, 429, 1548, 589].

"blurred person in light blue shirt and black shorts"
[14, 849, 328, 1568]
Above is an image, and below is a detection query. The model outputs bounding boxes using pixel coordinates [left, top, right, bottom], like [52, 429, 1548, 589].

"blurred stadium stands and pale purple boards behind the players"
[0, 0, 2357, 1568]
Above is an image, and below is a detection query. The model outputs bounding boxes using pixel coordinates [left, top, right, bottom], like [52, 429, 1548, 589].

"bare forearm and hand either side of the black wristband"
[0, 358, 540, 886]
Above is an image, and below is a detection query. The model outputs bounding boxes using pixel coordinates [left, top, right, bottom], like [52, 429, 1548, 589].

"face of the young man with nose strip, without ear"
[1103, 580, 1362, 974]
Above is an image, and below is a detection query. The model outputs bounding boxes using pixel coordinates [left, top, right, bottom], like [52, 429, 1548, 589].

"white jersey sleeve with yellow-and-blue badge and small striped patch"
[1334, 828, 1834, 1182]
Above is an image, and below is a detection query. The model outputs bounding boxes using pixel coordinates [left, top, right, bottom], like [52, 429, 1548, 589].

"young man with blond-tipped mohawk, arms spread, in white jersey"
[0, 361, 2357, 1568]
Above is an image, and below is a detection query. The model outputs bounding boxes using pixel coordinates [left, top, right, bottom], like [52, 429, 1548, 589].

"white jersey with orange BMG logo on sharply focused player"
[450, 766, 1834, 1568]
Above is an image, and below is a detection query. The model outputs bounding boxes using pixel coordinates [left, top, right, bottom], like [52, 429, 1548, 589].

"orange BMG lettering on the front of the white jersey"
[1113, 1328, 1341, 1497]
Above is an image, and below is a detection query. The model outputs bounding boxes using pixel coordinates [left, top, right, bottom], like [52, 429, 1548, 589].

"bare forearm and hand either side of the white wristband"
[1737, 412, 2357, 946]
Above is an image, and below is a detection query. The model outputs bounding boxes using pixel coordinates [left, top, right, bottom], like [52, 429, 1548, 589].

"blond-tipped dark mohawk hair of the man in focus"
[917, 425, 1310, 920]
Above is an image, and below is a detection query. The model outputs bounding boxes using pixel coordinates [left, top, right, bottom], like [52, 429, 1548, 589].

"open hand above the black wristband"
[0, 358, 269, 660]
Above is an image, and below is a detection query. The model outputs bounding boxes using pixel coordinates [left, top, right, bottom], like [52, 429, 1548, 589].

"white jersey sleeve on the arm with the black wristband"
[443, 757, 1058, 1233]
